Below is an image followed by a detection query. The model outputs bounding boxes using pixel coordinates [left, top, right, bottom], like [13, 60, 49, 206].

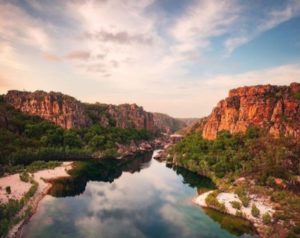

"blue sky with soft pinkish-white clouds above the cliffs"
[0, 0, 300, 117]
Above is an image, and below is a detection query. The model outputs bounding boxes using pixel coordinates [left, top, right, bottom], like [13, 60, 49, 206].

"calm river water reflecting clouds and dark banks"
[22, 154, 253, 238]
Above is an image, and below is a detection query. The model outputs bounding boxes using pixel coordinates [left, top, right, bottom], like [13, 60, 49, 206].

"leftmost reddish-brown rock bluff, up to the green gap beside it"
[5, 90, 91, 129]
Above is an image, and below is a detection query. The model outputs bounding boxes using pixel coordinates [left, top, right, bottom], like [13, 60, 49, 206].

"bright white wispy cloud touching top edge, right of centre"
[171, 0, 240, 52]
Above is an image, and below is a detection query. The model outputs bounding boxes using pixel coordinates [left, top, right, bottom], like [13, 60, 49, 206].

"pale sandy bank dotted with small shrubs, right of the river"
[192, 190, 274, 237]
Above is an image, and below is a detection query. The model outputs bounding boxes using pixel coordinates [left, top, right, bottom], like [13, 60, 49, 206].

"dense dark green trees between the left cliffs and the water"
[0, 97, 151, 175]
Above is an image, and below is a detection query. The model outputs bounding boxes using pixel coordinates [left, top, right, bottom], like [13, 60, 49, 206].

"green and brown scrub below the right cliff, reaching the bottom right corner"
[170, 128, 300, 237]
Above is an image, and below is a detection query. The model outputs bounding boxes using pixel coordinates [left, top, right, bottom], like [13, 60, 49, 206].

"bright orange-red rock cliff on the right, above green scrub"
[201, 83, 300, 140]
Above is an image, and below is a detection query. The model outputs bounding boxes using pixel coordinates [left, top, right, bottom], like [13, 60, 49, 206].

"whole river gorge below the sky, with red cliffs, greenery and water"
[0, 83, 300, 237]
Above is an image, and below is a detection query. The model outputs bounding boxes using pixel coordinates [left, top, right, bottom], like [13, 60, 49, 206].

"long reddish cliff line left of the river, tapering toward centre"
[4, 90, 186, 133]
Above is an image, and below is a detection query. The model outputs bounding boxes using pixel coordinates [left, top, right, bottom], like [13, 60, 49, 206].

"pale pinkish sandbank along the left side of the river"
[0, 162, 73, 238]
